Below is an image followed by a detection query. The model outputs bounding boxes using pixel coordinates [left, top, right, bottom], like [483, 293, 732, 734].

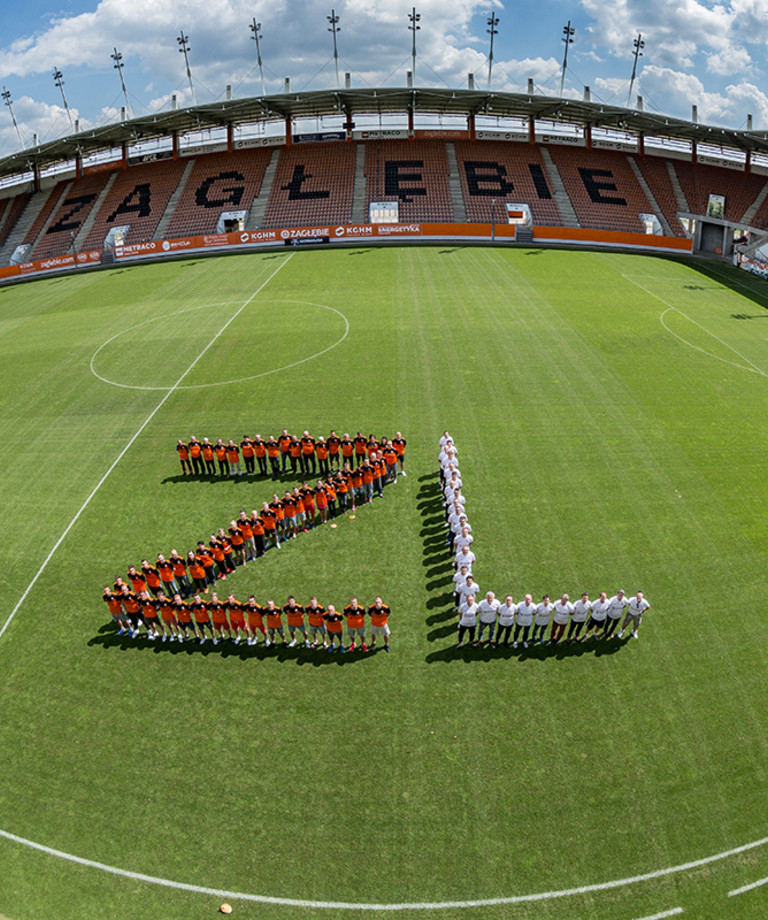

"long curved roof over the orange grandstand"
[0, 87, 768, 177]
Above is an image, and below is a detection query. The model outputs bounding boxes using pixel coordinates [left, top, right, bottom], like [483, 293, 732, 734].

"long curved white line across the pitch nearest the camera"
[0, 830, 768, 908]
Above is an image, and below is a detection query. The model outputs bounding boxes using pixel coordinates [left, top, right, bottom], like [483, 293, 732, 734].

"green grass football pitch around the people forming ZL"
[0, 247, 768, 920]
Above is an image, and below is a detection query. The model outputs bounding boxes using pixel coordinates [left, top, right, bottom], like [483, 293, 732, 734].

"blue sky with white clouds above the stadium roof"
[0, 0, 768, 156]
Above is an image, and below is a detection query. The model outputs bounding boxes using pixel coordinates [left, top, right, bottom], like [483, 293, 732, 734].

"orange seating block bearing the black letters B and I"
[454, 141, 562, 227]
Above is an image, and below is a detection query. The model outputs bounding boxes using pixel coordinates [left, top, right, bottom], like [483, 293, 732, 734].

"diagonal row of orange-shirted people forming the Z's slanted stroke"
[116, 454, 396, 598]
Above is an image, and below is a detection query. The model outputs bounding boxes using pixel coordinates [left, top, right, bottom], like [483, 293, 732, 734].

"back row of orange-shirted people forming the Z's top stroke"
[176, 428, 406, 481]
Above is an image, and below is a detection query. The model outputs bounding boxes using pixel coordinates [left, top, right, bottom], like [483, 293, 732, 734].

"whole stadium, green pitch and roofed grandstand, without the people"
[0, 12, 768, 920]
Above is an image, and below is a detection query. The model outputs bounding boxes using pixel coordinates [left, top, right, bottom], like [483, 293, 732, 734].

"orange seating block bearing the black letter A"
[81, 159, 186, 250]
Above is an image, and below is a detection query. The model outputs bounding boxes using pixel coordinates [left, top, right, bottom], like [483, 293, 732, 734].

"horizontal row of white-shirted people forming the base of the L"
[454, 588, 651, 648]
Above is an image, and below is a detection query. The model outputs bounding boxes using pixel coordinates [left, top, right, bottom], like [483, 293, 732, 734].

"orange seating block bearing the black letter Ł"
[263, 142, 357, 229]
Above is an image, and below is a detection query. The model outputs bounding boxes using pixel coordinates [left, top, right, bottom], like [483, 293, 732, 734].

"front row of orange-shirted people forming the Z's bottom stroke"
[102, 582, 392, 652]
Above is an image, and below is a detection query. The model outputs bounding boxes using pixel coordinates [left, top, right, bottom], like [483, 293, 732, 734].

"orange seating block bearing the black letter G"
[164, 147, 272, 239]
